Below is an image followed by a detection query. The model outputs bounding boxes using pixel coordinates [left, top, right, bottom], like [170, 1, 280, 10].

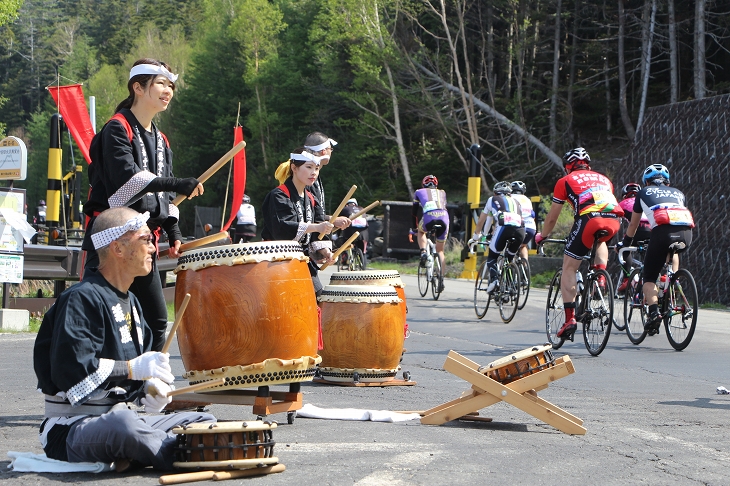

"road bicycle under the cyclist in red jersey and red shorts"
[538, 230, 613, 356]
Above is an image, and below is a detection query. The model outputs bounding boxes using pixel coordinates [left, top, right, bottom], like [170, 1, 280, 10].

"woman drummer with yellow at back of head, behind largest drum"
[261, 148, 334, 294]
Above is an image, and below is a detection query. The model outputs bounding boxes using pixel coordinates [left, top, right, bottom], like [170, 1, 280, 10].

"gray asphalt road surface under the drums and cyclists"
[0, 268, 730, 486]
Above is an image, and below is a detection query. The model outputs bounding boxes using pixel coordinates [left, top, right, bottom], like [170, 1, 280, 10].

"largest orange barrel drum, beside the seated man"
[175, 241, 321, 391]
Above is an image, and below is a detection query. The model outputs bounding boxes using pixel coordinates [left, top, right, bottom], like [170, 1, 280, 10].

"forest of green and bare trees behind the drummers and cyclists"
[0, 0, 730, 234]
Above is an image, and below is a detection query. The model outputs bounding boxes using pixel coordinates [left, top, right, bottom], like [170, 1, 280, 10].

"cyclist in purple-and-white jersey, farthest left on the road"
[413, 174, 449, 292]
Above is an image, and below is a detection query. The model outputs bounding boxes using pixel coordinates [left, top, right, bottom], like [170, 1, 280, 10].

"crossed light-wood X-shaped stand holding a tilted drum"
[421, 351, 586, 435]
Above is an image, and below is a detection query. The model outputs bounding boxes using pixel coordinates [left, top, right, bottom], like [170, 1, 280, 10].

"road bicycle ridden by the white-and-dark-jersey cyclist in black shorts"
[469, 238, 524, 324]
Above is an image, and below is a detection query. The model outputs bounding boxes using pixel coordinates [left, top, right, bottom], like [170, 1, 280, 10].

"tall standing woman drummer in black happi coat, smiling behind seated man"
[82, 59, 203, 351]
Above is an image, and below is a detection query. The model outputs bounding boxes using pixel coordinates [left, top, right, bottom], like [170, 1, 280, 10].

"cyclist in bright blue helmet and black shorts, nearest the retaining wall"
[619, 164, 695, 336]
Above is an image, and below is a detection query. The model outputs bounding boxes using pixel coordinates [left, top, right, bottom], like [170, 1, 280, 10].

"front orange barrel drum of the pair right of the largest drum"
[319, 285, 404, 383]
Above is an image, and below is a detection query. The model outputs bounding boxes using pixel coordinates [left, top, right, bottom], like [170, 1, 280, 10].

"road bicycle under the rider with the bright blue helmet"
[619, 242, 699, 351]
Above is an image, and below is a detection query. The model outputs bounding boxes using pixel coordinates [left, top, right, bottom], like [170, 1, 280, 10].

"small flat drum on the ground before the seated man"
[172, 420, 279, 469]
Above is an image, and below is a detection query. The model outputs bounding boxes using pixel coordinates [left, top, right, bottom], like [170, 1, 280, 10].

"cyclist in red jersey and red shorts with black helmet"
[535, 147, 624, 338]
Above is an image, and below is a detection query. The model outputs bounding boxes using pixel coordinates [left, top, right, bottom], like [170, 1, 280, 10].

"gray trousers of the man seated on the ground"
[66, 407, 216, 470]
